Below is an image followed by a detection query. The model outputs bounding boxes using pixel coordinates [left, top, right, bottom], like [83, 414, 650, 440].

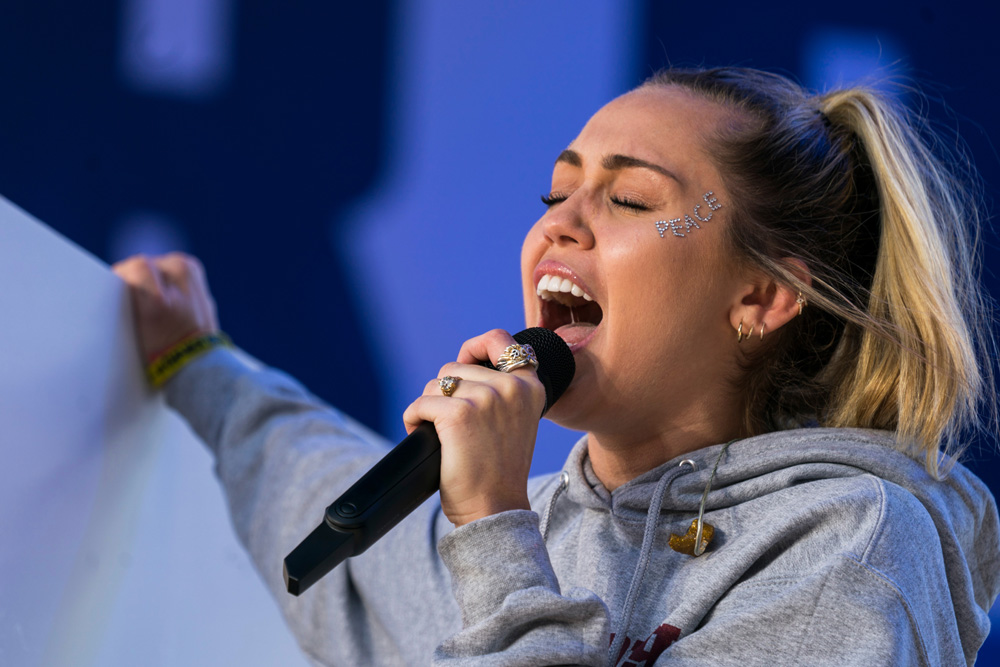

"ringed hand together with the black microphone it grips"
[284, 328, 576, 595]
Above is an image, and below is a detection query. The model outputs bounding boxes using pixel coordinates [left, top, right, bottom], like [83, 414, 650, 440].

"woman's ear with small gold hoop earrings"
[729, 257, 812, 341]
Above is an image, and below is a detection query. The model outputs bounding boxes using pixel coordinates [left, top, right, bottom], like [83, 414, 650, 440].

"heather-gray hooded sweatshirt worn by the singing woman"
[166, 349, 1000, 666]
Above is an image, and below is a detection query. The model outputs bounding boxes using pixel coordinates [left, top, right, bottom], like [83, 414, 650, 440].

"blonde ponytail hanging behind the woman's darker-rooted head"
[820, 89, 985, 475]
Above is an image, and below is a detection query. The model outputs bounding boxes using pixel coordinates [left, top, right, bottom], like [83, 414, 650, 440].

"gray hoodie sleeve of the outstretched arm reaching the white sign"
[165, 349, 459, 665]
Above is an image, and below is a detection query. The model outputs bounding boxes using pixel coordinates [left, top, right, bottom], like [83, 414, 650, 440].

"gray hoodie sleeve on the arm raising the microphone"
[434, 510, 609, 666]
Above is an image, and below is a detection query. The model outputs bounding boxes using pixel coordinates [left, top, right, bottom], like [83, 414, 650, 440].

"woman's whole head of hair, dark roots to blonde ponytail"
[644, 68, 995, 477]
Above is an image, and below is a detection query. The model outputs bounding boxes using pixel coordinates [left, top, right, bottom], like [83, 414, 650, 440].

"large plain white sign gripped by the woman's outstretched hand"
[0, 198, 306, 667]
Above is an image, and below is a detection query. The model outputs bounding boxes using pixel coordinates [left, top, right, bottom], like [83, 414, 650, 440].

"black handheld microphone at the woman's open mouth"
[284, 327, 576, 595]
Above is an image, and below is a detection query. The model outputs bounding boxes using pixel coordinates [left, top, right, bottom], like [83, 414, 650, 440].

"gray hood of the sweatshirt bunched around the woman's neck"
[560, 428, 1000, 655]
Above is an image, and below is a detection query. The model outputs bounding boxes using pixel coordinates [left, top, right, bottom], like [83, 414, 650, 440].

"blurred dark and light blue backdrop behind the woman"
[0, 0, 1000, 662]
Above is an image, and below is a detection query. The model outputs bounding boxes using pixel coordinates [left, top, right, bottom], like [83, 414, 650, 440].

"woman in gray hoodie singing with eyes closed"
[116, 68, 1000, 666]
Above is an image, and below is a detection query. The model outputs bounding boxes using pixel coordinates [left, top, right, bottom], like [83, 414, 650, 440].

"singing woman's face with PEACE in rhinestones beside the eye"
[521, 88, 739, 438]
